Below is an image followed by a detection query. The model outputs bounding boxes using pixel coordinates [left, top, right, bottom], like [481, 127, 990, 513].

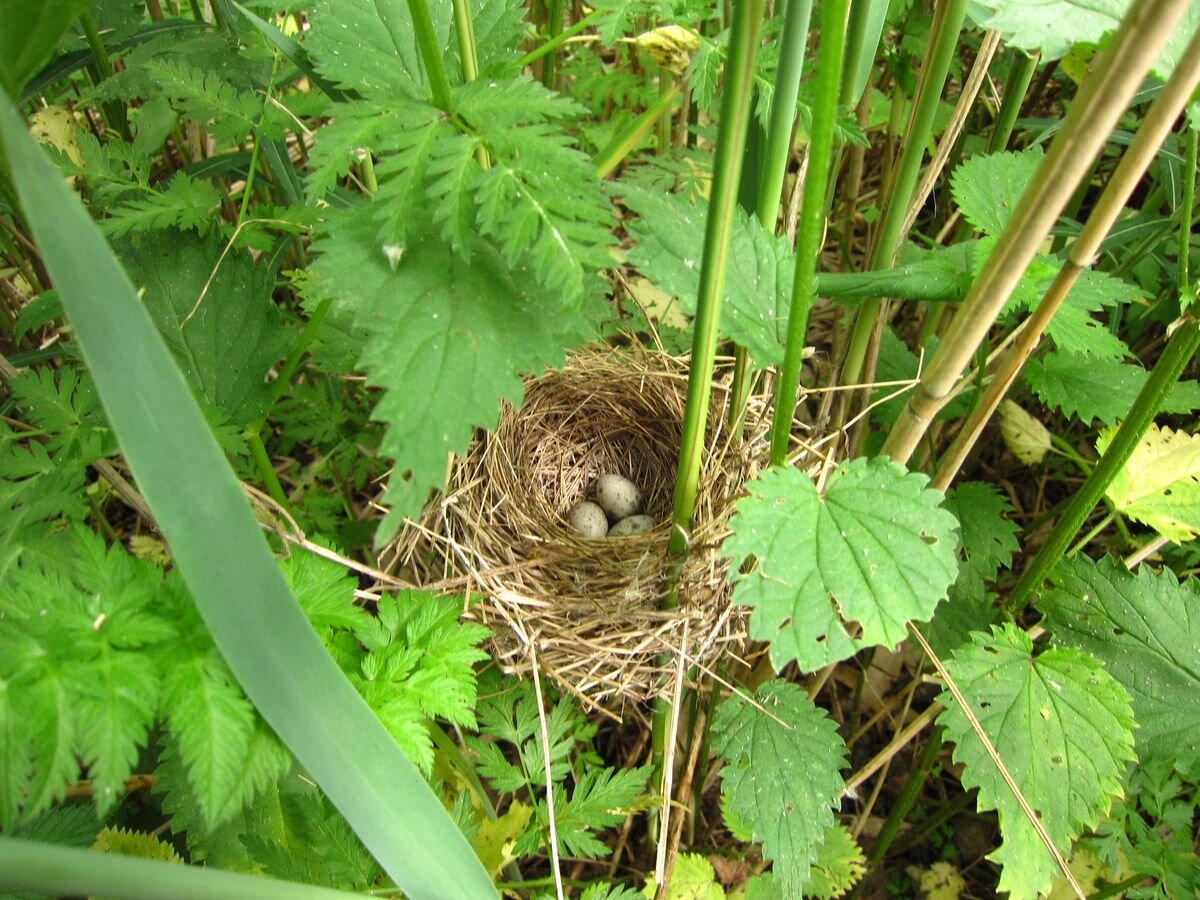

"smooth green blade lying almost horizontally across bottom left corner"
[0, 835, 360, 900]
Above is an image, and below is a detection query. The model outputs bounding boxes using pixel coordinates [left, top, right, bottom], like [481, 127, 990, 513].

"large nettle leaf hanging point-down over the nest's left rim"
[310, 205, 596, 541]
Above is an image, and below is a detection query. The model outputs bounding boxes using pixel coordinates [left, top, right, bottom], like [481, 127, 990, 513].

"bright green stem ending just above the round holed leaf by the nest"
[770, 0, 848, 466]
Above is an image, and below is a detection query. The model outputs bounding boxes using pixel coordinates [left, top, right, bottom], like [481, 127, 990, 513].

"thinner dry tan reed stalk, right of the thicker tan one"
[934, 31, 1200, 491]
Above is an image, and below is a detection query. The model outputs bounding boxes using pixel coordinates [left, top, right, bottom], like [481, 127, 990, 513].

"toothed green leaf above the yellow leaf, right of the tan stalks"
[1022, 350, 1200, 425]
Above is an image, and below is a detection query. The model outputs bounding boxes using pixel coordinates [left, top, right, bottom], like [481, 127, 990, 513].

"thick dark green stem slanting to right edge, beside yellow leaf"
[1004, 317, 1200, 614]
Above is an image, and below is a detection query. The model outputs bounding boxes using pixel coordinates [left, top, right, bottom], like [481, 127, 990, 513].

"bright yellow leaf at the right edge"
[1096, 424, 1200, 544]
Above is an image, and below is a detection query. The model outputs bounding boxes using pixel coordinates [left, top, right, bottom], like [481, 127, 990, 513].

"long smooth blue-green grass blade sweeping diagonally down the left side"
[0, 103, 496, 898]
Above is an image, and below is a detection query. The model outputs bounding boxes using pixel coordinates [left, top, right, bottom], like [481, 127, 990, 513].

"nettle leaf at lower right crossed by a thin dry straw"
[938, 624, 1135, 900]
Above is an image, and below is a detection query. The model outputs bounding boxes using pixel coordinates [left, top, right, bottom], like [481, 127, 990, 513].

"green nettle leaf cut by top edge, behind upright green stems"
[304, 0, 452, 97]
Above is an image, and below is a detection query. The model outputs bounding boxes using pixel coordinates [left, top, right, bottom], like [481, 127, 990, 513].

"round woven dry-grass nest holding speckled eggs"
[391, 347, 811, 707]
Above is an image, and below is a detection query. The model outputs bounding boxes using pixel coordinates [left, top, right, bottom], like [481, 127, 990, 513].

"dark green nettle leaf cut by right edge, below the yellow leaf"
[1038, 558, 1200, 762]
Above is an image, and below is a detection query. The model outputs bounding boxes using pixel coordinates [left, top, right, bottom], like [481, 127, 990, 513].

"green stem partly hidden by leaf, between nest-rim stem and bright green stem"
[730, 0, 812, 433]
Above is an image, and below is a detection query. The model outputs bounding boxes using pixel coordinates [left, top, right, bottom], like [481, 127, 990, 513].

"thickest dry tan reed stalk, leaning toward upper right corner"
[881, 0, 1188, 462]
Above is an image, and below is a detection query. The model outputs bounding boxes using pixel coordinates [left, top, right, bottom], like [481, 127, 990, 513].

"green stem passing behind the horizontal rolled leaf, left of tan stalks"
[841, 0, 967, 384]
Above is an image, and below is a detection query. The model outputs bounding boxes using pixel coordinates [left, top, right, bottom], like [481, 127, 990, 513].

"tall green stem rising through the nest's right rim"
[652, 0, 766, 768]
